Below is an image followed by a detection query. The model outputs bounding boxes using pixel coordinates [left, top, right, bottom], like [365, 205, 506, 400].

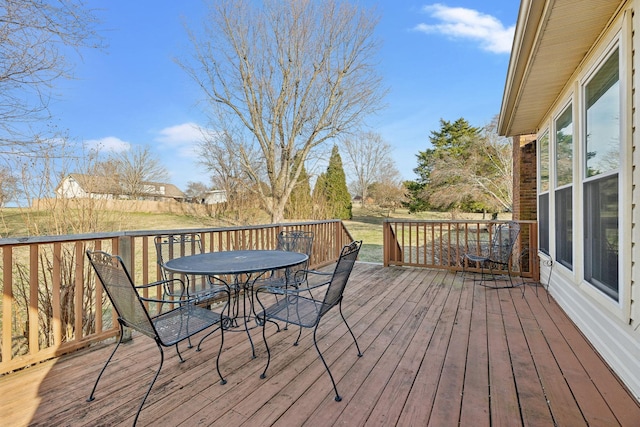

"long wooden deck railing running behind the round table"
[0, 220, 352, 375]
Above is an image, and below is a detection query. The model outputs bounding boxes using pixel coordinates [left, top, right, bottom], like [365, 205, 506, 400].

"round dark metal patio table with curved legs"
[165, 250, 309, 357]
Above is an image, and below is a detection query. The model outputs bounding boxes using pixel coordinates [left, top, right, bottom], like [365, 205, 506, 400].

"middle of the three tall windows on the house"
[555, 105, 573, 268]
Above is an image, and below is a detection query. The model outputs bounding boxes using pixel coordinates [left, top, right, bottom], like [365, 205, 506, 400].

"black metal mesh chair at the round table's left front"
[86, 250, 228, 425]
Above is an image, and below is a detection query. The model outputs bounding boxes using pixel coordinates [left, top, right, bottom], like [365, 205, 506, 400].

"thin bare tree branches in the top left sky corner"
[0, 0, 100, 156]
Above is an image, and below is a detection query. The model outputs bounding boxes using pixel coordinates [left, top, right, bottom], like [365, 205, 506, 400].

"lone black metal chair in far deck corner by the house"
[462, 221, 520, 288]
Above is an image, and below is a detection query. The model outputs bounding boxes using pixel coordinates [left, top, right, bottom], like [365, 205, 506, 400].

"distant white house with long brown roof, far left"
[56, 173, 184, 201]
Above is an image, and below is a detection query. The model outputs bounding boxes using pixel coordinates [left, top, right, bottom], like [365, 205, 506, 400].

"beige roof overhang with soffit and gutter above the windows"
[498, 0, 622, 136]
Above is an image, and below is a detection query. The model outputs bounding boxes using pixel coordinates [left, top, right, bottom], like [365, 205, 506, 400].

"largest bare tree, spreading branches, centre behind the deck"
[181, 0, 383, 222]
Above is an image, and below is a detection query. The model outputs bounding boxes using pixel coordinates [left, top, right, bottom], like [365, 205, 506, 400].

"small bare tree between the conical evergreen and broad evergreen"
[343, 132, 400, 206]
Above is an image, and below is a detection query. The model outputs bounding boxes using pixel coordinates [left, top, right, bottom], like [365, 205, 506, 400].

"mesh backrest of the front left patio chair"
[87, 250, 156, 338]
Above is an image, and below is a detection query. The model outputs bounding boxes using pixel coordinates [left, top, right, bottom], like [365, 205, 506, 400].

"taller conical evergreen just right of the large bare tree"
[313, 145, 353, 219]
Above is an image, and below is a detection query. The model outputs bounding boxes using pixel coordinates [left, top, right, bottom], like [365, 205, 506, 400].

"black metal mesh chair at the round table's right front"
[256, 241, 362, 402]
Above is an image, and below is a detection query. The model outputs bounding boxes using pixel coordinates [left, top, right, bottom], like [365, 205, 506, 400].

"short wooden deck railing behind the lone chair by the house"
[383, 219, 539, 280]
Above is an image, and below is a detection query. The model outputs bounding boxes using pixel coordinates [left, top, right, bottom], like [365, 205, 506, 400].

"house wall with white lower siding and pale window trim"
[520, 0, 640, 400]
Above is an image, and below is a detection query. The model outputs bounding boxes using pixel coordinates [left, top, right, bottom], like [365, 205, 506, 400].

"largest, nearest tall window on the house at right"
[583, 49, 621, 301]
